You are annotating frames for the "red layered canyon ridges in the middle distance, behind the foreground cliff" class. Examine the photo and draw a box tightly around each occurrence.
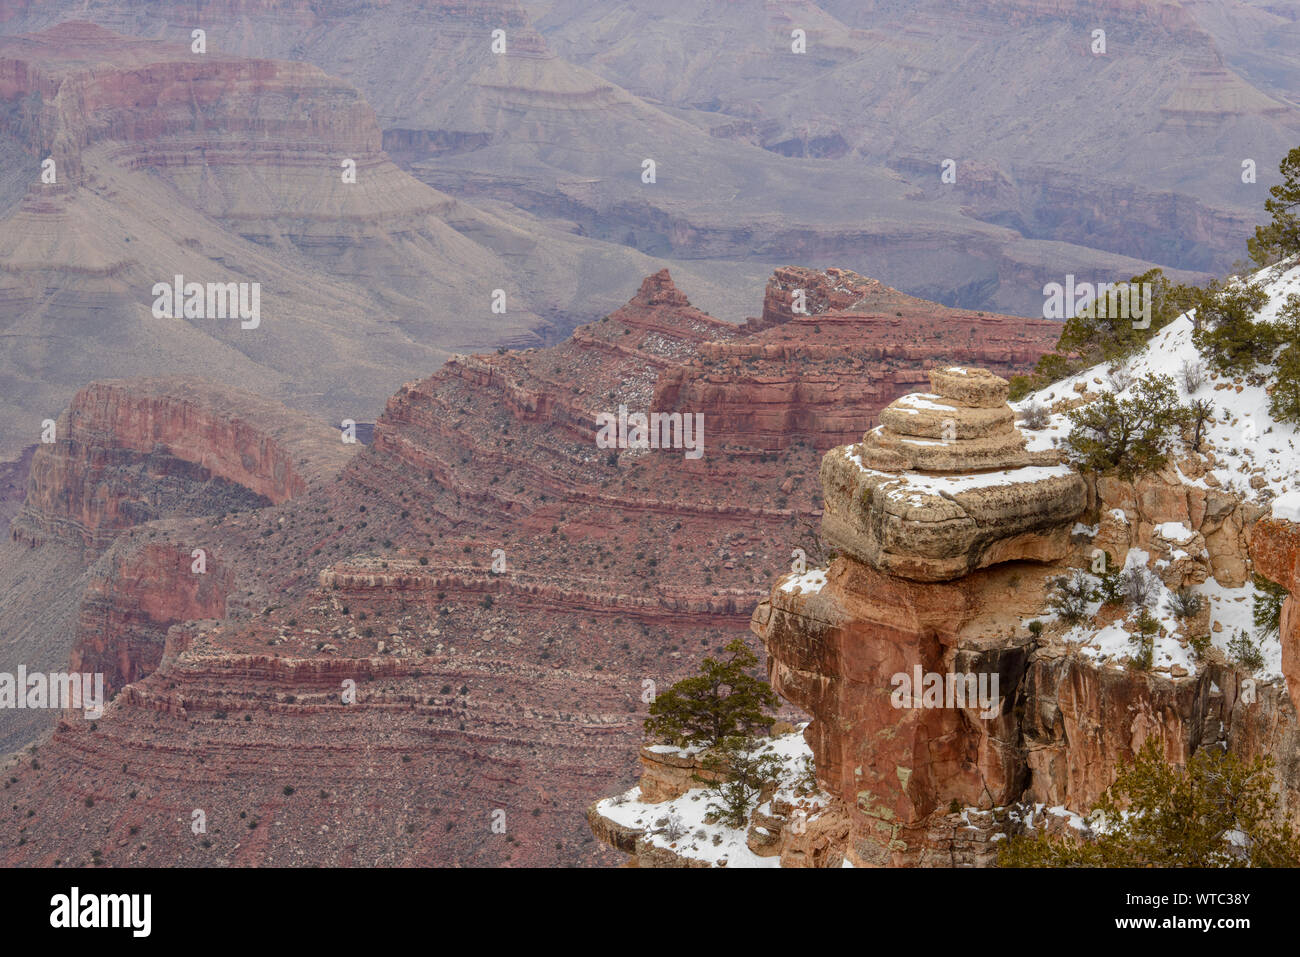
[0,267,1057,865]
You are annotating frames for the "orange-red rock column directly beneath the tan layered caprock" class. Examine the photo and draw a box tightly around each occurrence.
[754,558,1030,863]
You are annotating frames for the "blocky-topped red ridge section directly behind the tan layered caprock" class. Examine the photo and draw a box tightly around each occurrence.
[654,267,1061,454]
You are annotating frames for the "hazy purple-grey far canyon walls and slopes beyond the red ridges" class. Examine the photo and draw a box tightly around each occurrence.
[0,0,1279,475]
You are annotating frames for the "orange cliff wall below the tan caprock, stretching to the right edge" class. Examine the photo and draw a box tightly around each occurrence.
[753,479,1300,866]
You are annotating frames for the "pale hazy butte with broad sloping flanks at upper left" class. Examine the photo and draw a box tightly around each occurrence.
[0,21,762,460]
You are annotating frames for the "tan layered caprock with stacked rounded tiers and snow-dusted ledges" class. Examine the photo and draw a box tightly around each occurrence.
[822,368,1087,581]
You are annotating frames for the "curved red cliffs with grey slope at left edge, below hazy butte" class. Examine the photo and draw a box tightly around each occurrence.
[0,378,356,744]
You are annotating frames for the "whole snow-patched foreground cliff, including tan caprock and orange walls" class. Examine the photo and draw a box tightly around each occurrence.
[589,261,1300,866]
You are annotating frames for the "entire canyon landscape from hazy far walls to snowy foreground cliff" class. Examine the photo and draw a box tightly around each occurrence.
[0,0,1300,867]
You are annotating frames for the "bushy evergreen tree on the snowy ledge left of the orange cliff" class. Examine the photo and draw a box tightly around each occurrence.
[645,638,780,748]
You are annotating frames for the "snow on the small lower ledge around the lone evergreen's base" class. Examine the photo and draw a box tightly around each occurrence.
[597,724,831,867]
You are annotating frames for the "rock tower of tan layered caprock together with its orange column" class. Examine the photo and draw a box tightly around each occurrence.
[753,367,1087,865]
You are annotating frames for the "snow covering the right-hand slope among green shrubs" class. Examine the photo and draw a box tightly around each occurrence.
[1011,267,1300,680]
